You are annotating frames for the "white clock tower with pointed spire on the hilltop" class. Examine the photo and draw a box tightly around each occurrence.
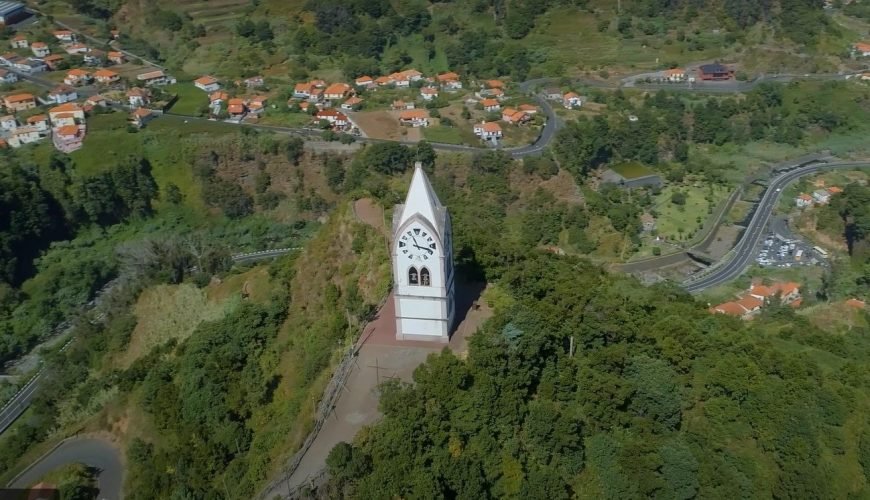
[393,162,456,342]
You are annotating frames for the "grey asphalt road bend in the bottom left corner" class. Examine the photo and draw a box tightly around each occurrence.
[8,438,124,500]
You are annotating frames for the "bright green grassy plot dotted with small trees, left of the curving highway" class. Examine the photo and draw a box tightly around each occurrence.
[655,186,728,240]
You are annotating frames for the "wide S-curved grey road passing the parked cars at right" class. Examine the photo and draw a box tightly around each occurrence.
[683,162,870,293]
